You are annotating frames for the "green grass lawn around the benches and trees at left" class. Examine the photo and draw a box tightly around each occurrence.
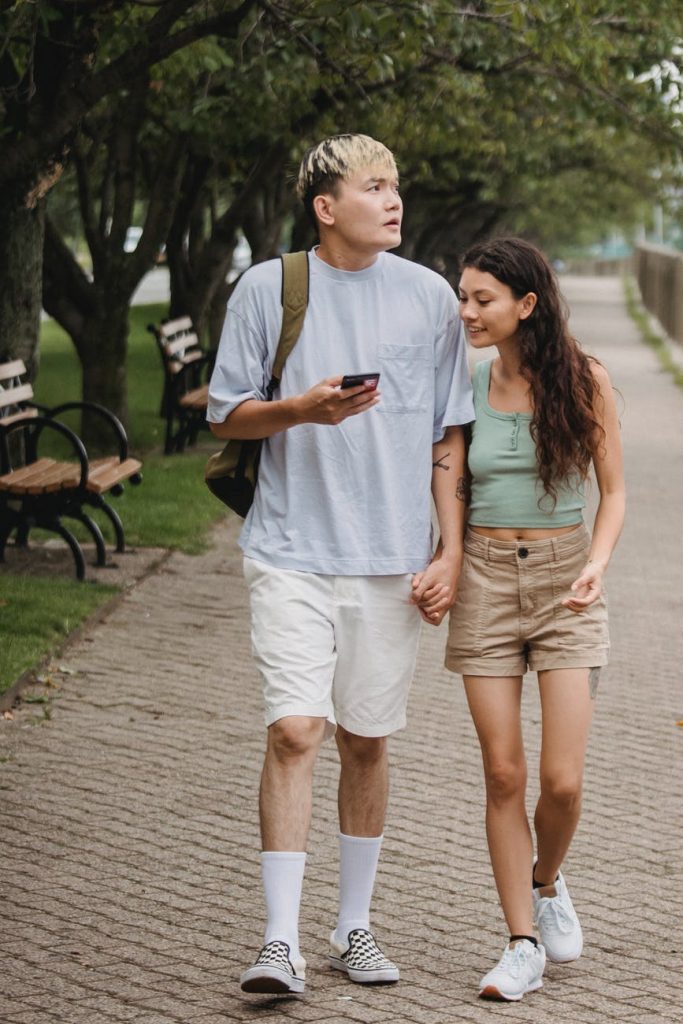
[0,305,231,693]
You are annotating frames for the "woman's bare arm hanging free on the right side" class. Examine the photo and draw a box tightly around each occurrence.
[562,362,626,611]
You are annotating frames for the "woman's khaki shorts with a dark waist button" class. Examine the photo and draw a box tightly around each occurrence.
[445,523,609,677]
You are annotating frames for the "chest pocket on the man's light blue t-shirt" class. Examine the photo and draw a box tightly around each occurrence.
[377,345,434,413]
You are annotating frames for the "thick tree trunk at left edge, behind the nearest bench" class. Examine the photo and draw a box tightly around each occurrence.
[0,185,45,380]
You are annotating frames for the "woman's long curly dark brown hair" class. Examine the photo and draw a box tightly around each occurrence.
[461,238,604,502]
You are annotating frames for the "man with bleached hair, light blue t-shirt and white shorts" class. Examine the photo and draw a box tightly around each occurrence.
[208,135,473,992]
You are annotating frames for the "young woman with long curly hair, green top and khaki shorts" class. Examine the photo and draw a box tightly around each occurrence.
[445,239,625,999]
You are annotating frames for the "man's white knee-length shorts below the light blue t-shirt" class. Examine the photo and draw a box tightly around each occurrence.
[244,557,422,736]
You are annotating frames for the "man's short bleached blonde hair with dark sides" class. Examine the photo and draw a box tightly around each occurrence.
[296,133,398,224]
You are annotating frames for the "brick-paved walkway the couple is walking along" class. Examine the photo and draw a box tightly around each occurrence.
[0,279,683,1024]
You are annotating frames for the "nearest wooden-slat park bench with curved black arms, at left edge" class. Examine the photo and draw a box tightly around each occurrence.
[0,359,142,580]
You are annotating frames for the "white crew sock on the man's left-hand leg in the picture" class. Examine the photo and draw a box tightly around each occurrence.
[261,850,306,959]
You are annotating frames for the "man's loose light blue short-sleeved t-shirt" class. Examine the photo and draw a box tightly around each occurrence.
[207,244,474,575]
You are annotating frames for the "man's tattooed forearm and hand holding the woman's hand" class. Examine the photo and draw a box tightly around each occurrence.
[413,427,466,626]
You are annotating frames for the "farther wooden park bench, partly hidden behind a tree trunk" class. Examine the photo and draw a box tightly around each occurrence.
[143,316,213,455]
